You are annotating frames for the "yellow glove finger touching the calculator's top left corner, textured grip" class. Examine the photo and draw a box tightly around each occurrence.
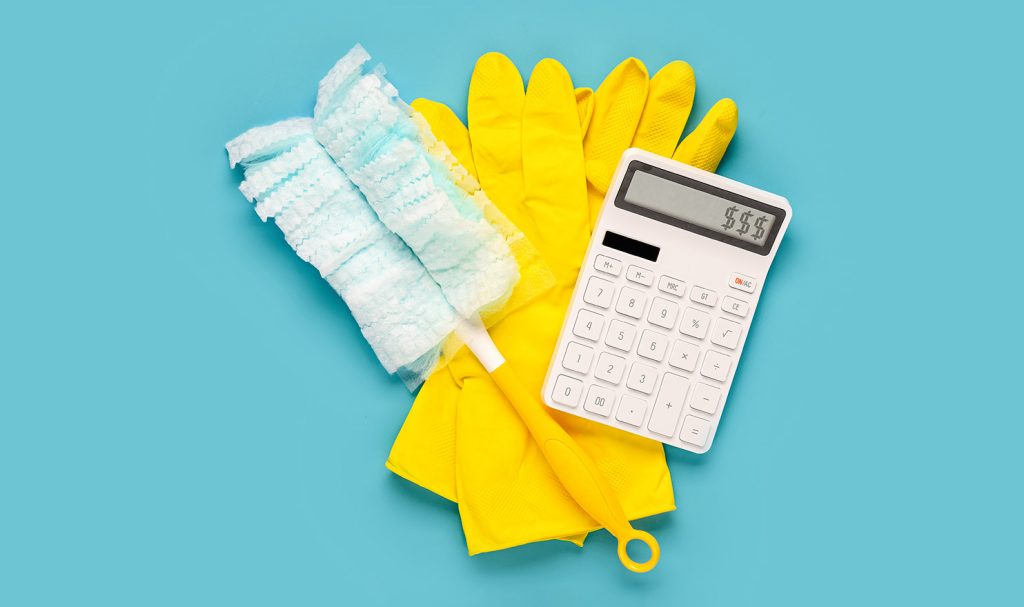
[584,57,648,192]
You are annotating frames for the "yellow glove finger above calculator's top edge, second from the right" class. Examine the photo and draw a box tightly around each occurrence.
[633,61,696,157]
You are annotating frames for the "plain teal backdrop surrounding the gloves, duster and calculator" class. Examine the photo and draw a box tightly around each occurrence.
[0,0,1024,606]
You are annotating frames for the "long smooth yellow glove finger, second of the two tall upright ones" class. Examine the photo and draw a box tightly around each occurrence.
[522,59,590,278]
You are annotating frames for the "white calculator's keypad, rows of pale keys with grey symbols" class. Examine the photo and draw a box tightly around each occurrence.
[551,249,756,449]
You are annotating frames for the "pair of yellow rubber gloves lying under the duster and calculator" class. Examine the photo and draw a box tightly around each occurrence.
[387,53,736,554]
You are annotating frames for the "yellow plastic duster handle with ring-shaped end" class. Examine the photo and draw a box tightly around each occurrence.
[490,362,662,573]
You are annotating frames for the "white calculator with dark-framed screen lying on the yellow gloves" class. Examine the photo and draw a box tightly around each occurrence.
[543,148,793,453]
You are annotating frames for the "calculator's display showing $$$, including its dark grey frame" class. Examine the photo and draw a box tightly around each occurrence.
[615,162,784,255]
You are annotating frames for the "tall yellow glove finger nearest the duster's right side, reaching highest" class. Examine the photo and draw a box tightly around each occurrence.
[467,52,525,218]
